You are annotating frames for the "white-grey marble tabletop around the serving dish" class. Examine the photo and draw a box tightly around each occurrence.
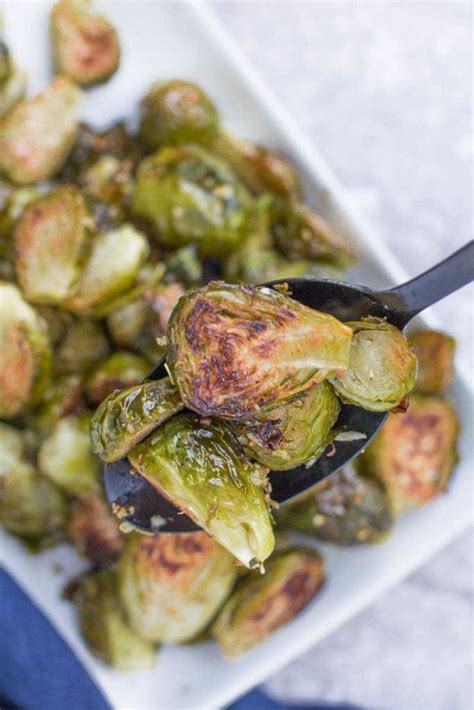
[213,0,473,710]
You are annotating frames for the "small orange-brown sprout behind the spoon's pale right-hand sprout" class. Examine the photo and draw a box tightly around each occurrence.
[409,330,456,394]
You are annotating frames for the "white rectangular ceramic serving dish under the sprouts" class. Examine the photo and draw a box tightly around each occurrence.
[0,0,472,710]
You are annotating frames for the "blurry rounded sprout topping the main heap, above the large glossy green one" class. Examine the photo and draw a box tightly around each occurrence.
[140,80,219,149]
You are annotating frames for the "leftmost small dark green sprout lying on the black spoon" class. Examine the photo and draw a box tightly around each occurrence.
[90,377,183,463]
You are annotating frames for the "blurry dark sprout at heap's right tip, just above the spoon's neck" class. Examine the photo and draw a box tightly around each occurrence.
[272,200,355,271]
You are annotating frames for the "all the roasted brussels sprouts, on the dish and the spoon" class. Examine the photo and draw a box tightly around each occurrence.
[0,0,459,670]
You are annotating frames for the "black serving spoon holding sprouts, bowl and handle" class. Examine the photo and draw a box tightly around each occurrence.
[104,241,474,533]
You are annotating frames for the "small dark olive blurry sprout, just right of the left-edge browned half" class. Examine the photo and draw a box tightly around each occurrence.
[54,316,110,375]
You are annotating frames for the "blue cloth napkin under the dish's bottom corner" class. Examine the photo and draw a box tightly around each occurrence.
[0,569,357,710]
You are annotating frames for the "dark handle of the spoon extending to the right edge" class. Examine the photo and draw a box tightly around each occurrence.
[383,240,474,325]
